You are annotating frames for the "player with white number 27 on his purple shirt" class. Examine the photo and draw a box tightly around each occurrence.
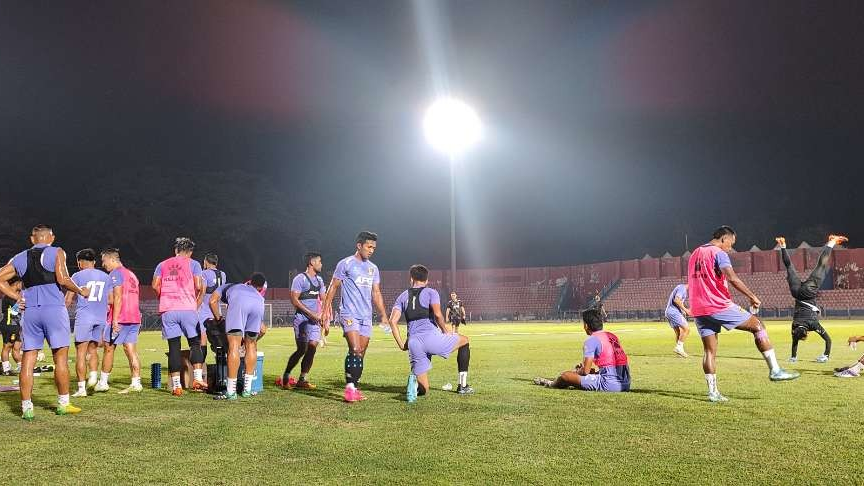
[66,248,111,398]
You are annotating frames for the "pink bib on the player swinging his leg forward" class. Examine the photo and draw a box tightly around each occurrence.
[687,244,732,316]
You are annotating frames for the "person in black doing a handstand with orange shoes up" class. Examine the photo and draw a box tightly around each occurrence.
[775,235,849,363]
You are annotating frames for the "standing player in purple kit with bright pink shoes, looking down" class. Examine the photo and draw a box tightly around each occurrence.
[322,231,390,402]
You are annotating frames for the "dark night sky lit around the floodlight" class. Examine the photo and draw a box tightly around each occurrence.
[0,0,864,282]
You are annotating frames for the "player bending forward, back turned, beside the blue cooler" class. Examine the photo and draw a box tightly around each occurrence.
[210,273,267,400]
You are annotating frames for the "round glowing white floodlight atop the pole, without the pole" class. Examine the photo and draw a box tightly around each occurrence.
[423,98,482,160]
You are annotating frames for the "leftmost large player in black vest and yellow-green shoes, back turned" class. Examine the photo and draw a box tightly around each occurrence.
[0,225,90,421]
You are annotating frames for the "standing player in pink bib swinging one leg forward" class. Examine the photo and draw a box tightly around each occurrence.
[687,226,800,402]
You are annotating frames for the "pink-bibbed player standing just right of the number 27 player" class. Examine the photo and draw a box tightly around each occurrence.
[96,248,143,394]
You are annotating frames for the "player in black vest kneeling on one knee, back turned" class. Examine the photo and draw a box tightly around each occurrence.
[390,265,474,402]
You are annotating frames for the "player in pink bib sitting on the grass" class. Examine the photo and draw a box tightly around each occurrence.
[534,309,630,392]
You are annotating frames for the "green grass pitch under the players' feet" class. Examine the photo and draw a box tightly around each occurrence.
[0,321,864,484]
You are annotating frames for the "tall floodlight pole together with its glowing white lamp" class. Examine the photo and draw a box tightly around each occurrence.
[423,97,482,292]
